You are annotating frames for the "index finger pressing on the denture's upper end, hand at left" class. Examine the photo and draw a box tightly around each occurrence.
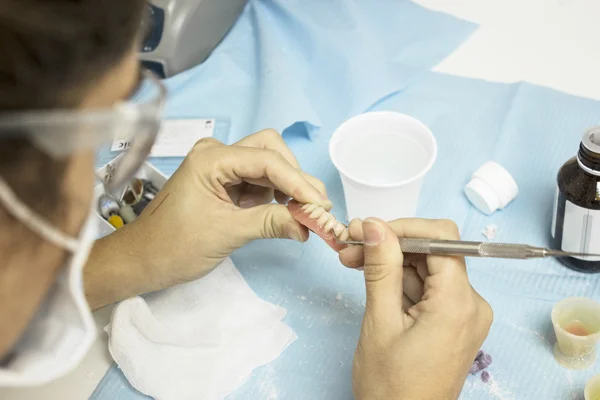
[216,146,331,208]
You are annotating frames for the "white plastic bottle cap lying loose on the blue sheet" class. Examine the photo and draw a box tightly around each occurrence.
[465,161,519,215]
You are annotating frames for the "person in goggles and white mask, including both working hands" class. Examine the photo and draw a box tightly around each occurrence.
[0,0,492,400]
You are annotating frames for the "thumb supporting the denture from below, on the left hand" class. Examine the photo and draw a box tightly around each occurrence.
[238,204,308,242]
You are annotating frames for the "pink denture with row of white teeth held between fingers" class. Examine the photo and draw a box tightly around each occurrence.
[288,200,350,251]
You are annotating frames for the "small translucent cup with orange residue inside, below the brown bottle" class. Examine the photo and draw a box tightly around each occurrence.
[551,297,600,369]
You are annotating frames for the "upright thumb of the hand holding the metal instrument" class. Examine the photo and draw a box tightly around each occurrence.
[362,218,403,321]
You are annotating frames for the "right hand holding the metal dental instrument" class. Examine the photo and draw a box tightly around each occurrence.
[340,219,493,400]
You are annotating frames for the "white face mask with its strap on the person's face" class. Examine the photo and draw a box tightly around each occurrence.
[0,178,97,386]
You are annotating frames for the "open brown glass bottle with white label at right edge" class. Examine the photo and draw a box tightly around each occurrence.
[552,127,600,273]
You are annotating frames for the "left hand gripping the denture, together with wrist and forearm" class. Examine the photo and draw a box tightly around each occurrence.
[84,130,332,308]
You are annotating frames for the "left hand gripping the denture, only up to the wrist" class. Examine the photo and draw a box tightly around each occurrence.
[142,130,332,285]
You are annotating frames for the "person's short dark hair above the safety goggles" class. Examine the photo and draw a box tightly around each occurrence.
[0,0,145,111]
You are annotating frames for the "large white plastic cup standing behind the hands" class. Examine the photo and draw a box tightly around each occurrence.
[329,111,437,221]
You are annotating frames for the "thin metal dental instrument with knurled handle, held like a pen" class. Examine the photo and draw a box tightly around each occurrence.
[338,238,600,259]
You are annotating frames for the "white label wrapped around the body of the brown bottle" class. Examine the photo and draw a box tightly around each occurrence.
[553,200,600,261]
